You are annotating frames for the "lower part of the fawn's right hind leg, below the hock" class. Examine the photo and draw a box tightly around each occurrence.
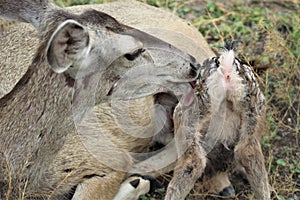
[235,135,270,200]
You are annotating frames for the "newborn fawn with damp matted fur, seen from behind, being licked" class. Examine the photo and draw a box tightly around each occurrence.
[166,41,270,200]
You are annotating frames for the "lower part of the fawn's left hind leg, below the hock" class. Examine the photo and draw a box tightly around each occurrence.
[165,143,206,200]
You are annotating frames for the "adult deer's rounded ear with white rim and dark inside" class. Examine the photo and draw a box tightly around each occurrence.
[46,20,90,73]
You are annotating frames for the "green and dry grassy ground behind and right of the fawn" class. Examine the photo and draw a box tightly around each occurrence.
[55,0,300,200]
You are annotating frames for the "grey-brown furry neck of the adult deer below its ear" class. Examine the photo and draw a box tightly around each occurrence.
[0,49,73,179]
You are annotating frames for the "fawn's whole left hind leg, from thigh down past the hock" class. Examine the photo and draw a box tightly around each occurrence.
[165,92,206,200]
